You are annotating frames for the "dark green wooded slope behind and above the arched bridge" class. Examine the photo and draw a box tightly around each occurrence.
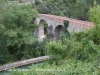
[36,0,100,20]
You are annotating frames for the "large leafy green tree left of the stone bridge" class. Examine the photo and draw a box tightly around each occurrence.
[0,4,38,61]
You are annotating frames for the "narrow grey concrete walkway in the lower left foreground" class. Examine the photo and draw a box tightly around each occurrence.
[0,56,50,71]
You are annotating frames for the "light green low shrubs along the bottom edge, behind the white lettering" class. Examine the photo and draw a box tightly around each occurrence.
[8,59,100,75]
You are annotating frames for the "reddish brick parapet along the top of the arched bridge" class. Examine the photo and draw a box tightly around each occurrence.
[40,14,95,29]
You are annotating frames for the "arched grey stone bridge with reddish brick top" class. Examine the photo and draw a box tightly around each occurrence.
[34,14,94,40]
